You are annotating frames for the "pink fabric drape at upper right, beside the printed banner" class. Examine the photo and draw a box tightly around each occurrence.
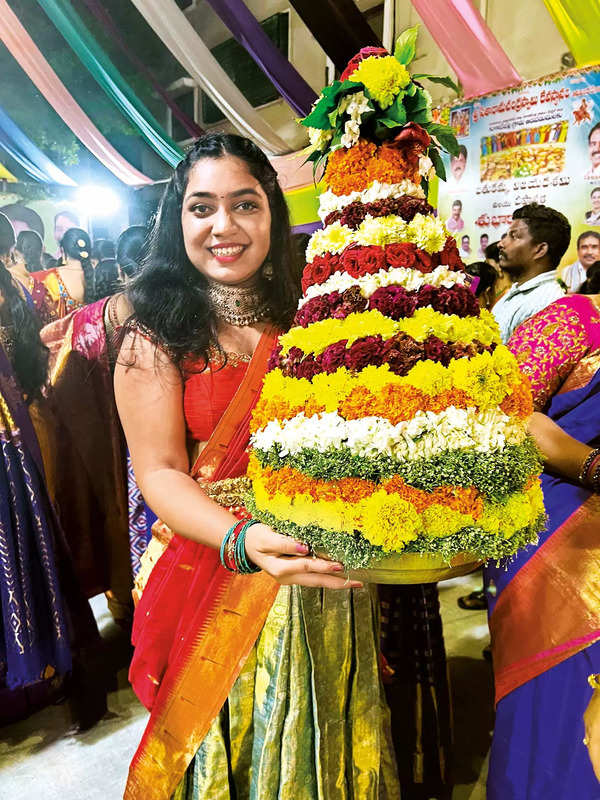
[412,0,523,99]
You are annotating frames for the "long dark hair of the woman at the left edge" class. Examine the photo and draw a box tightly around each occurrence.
[0,214,48,401]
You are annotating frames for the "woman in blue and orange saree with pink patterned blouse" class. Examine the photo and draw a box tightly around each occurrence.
[486,295,600,800]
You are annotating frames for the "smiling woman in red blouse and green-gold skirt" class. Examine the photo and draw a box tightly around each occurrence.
[115,134,399,800]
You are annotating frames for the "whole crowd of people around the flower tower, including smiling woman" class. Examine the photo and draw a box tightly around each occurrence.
[0,134,600,800]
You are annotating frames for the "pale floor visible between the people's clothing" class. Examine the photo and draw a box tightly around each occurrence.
[0,575,492,800]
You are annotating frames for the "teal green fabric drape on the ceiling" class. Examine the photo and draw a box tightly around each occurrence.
[38,0,183,167]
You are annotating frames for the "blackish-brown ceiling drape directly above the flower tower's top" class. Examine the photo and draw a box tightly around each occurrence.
[291,0,381,72]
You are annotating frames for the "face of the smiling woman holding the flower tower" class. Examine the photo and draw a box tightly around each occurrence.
[181,156,271,286]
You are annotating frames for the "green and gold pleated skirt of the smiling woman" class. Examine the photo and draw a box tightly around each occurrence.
[173,586,400,800]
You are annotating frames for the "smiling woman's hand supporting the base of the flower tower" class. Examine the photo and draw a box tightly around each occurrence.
[246,524,362,589]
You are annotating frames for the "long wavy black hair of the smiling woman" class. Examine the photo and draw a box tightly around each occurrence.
[128,133,300,366]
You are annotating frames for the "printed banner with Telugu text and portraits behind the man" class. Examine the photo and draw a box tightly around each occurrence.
[437,66,600,264]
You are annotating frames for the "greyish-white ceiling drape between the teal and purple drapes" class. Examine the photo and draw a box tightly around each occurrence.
[132,0,290,155]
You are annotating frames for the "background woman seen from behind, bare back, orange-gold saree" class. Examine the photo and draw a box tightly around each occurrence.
[44,228,94,317]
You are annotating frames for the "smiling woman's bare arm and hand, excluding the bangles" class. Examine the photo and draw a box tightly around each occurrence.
[115,334,360,588]
